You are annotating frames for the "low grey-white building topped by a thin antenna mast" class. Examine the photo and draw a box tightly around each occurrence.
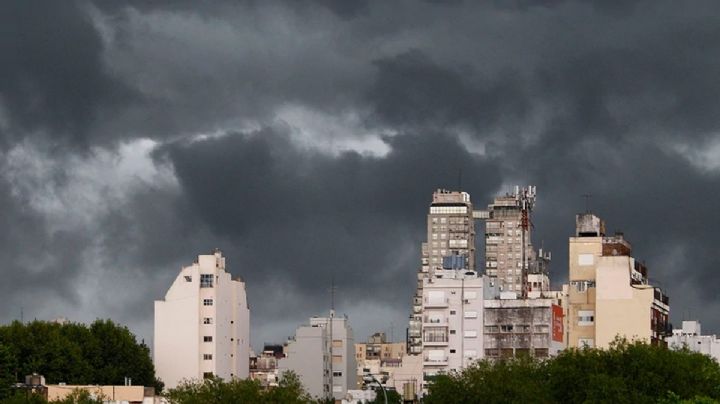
[278,313,357,400]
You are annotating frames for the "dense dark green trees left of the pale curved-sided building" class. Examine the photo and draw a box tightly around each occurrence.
[0,320,163,399]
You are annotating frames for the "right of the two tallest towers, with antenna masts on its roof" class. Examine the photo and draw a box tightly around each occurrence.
[476,186,550,298]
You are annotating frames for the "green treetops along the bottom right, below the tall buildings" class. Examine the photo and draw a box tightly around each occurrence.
[425,340,720,404]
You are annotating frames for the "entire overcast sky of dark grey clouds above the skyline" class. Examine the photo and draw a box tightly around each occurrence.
[0,0,720,347]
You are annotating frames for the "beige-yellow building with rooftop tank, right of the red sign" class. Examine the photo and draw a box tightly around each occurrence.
[566,213,670,348]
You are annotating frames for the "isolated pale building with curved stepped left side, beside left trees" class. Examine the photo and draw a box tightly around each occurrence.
[153,250,250,388]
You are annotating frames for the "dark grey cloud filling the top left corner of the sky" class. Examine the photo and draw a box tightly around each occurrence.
[0,1,131,145]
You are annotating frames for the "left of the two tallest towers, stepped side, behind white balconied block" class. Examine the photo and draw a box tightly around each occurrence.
[407,189,475,355]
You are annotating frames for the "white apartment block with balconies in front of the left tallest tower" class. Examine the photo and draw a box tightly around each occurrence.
[422,269,484,390]
